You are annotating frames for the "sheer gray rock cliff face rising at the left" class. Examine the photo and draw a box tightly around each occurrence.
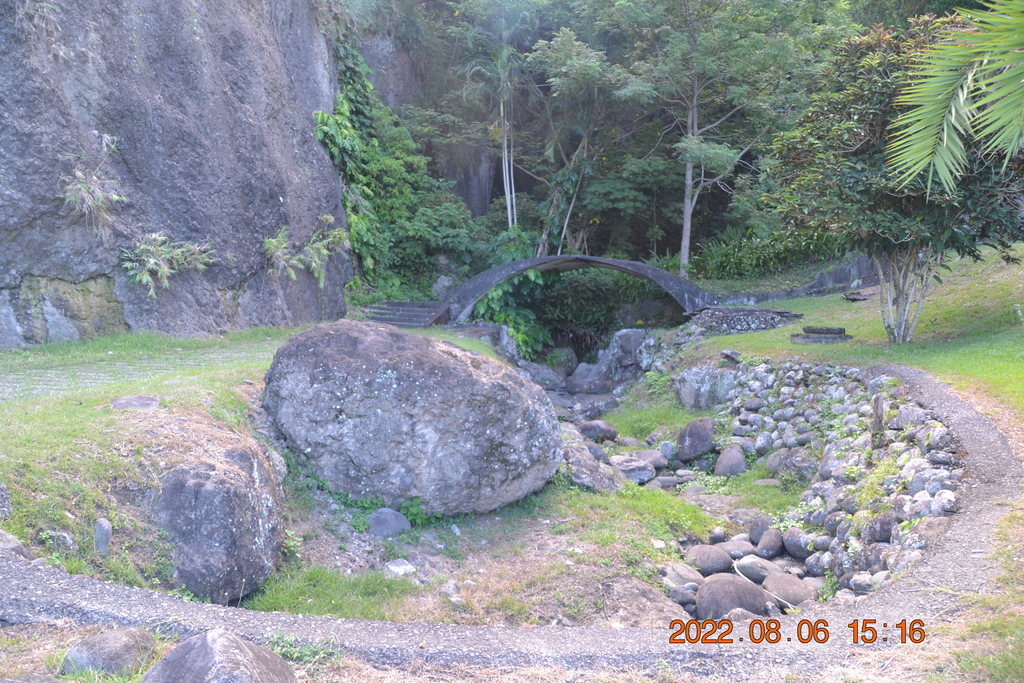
[0,0,350,347]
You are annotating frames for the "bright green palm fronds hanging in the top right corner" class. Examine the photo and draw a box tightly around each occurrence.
[889,0,1024,191]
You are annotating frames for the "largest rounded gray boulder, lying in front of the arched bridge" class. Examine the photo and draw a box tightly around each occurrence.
[263,321,562,515]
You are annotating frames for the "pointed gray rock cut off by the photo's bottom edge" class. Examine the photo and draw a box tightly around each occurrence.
[142,629,295,683]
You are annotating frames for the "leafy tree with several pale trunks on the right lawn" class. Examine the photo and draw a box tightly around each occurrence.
[772,17,1020,343]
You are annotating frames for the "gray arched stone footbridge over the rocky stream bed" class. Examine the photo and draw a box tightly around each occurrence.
[444,254,718,321]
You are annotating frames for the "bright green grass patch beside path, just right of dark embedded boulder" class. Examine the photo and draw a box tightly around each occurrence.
[242,567,419,622]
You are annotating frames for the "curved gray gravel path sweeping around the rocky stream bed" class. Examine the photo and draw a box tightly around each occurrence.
[0,366,1024,680]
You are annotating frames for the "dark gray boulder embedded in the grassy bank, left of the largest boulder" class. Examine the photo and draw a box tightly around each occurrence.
[156,449,283,604]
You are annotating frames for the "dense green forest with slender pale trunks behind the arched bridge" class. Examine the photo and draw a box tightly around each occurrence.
[317,0,1019,352]
